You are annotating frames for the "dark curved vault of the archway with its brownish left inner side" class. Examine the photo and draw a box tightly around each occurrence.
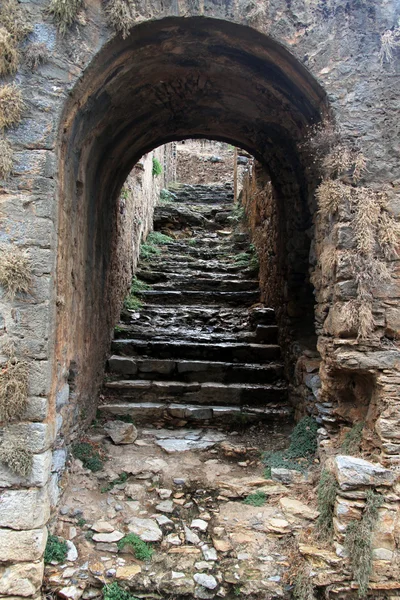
[55,17,327,446]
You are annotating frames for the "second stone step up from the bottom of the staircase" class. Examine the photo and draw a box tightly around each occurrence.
[104,379,287,406]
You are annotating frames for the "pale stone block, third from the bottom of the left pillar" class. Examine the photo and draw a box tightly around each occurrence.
[0,487,50,529]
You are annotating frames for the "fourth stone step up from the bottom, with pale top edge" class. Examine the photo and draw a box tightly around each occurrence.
[111,339,280,363]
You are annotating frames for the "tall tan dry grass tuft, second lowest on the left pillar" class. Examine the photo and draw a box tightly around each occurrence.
[0,356,28,422]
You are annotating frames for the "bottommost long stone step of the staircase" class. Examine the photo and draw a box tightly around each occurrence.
[99,402,293,427]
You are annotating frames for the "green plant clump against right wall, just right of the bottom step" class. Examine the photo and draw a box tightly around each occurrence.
[263,417,318,478]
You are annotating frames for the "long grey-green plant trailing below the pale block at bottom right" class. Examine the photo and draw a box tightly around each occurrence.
[344,490,383,598]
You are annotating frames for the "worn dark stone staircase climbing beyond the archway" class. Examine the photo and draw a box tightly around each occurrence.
[99,185,291,425]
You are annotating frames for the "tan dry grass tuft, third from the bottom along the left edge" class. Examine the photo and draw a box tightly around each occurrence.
[0,247,32,299]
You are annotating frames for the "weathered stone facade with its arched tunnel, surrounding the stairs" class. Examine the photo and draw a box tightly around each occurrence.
[0,0,400,597]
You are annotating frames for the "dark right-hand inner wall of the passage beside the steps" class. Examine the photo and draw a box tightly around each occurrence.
[240,163,321,417]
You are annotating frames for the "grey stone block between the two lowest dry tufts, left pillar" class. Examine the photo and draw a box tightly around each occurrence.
[2,423,55,454]
